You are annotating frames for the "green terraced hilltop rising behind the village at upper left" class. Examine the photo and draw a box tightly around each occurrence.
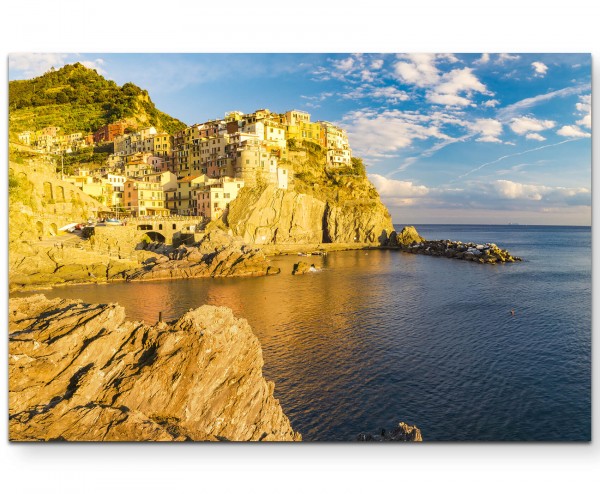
[8,63,185,134]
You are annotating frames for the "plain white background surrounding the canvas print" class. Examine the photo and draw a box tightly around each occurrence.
[0,0,600,494]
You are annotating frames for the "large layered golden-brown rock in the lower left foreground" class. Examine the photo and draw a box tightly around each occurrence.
[9,295,301,441]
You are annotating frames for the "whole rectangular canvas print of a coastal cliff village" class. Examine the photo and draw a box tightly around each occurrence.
[7,53,592,442]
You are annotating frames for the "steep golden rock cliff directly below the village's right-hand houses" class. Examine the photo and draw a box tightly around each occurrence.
[225,149,393,245]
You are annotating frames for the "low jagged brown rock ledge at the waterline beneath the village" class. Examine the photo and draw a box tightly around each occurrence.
[127,245,279,281]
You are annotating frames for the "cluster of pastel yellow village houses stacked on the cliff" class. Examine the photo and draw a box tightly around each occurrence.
[18,109,352,220]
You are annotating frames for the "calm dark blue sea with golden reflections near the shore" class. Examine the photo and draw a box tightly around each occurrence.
[22,225,592,441]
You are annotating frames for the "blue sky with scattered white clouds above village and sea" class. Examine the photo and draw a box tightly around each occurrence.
[9,53,592,225]
